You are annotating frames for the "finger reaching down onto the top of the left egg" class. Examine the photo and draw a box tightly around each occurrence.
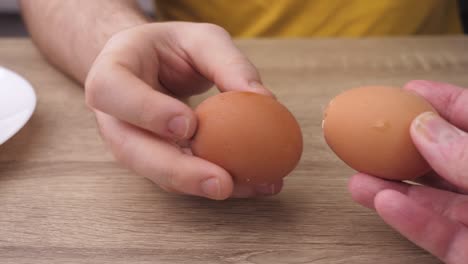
[173,24,272,95]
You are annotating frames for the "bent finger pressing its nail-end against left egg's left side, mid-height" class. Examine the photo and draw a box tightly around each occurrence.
[86,60,196,139]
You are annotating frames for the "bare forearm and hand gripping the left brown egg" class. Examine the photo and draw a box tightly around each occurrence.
[20,0,282,200]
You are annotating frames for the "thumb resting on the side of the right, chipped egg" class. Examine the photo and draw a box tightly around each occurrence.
[411,112,468,190]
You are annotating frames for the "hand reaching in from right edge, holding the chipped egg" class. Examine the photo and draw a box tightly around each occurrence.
[349,81,468,264]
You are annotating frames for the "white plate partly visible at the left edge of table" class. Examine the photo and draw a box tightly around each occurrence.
[0,67,36,145]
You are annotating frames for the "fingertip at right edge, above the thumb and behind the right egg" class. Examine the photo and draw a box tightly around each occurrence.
[404,81,468,130]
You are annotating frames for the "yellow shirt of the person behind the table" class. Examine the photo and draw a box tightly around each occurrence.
[155,0,462,37]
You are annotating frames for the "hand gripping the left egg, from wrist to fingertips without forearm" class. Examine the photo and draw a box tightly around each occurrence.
[85,22,282,200]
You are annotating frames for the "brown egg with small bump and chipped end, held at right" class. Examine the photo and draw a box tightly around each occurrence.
[323,86,436,180]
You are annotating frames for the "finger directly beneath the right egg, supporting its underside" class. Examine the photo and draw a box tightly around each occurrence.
[348,174,468,225]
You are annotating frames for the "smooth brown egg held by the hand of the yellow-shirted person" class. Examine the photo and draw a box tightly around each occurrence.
[191,92,302,184]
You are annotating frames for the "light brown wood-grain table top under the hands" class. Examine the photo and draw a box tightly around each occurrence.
[0,37,468,264]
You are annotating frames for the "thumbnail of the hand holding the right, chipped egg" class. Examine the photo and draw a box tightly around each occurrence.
[413,112,461,144]
